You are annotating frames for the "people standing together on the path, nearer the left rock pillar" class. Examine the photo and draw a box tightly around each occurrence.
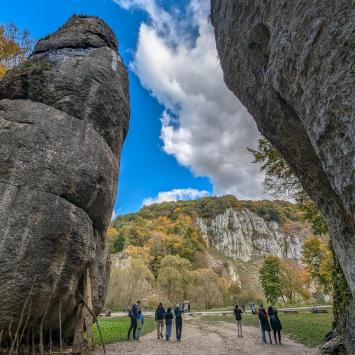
[127,301,185,341]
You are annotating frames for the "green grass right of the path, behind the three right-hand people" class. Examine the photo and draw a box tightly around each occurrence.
[201,312,332,347]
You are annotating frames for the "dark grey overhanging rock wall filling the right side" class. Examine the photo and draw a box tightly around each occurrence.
[211,0,355,354]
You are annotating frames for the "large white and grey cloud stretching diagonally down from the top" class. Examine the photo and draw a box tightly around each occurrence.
[115,0,266,199]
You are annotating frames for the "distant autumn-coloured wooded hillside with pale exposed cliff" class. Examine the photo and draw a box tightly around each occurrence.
[107,195,330,308]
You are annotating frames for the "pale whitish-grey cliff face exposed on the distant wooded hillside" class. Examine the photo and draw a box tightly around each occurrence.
[196,208,310,262]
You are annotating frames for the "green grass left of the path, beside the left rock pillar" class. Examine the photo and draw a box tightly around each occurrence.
[93,317,155,346]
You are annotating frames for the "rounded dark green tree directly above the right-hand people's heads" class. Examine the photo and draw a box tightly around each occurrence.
[259,256,283,304]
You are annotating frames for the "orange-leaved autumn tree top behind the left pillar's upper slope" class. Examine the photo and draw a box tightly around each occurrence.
[0,23,34,78]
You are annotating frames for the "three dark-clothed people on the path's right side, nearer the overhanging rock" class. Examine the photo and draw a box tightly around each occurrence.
[234,304,282,345]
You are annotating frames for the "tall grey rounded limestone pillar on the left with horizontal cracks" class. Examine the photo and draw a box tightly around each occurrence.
[0,16,129,348]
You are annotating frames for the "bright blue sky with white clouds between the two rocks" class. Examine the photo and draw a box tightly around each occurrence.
[0,0,263,214]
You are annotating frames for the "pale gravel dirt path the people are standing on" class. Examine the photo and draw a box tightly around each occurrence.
[95,320,319,355]
